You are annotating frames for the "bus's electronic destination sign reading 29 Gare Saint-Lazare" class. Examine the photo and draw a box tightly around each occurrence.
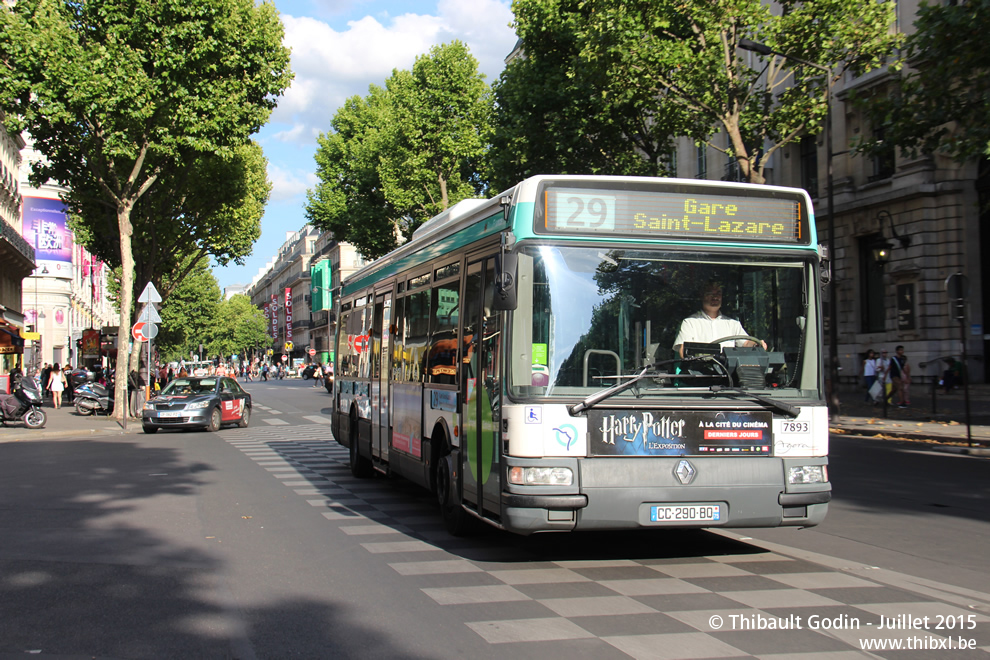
[543,187,808,243]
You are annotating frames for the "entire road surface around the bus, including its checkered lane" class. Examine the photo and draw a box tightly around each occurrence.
[0,380,990,660]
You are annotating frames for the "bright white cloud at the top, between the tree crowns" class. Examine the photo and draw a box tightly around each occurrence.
[272,0,516,144]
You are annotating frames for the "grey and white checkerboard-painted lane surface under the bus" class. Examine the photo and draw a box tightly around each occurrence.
[225,426,990,660]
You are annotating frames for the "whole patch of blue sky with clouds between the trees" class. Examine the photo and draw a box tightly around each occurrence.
[213,0,516,288]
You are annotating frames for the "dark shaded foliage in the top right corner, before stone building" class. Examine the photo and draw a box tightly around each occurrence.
[857,0,990,161]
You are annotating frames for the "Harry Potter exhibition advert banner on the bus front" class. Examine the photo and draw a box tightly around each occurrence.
[588,409,773,456]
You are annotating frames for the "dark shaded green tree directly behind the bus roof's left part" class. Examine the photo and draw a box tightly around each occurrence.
[490,0,697,190]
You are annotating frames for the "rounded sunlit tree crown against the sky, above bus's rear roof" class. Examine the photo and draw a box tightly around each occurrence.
[306,41,492,258]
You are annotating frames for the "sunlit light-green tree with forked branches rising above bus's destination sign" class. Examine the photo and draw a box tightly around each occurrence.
[508,0,898,183]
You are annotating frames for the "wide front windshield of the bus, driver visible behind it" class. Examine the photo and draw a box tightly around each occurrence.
[509,245,820,398]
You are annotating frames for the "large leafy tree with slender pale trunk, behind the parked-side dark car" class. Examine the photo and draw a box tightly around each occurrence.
[0,0,291,419]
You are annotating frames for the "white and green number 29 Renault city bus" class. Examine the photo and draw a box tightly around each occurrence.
[331,175,831,535]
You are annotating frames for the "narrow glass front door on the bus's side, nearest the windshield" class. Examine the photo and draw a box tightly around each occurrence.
[460,259,502,519]
